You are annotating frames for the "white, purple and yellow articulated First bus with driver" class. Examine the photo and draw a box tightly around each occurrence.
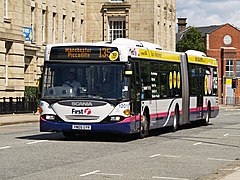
[39,38,219,138]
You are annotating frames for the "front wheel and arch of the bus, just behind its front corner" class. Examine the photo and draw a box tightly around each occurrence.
[139,107,150,139]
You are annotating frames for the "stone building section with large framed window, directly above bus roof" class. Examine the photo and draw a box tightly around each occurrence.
[86,0,176,50]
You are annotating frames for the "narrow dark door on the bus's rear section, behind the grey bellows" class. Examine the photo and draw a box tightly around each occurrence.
[195,66,204,119]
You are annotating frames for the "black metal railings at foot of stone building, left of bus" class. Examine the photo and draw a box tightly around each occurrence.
[0,97,37,114]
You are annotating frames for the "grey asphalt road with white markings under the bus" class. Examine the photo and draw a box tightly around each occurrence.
[0,110,240,180]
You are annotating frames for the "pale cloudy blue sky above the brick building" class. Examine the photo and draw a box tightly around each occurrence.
[176,0,240,28]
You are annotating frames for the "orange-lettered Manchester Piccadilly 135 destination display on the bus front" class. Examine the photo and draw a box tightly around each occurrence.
[50,46,119,61]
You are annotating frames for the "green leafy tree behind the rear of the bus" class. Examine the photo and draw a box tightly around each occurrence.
[177,27,206,52]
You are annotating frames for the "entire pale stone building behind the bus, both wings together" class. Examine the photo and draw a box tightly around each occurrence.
[0,0,176,98]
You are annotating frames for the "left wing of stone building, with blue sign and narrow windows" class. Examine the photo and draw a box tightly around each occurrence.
[0,0,85,97]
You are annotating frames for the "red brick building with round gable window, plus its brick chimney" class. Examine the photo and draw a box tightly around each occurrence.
[177,18,240,104]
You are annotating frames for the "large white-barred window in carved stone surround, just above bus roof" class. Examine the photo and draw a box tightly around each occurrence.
[108,17,126,41]
